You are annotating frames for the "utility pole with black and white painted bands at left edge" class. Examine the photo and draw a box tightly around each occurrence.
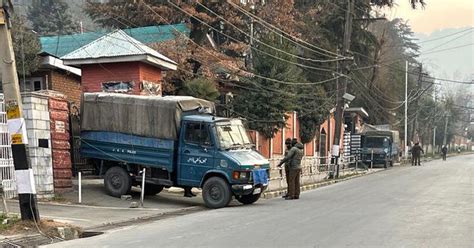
[0,0,39,221]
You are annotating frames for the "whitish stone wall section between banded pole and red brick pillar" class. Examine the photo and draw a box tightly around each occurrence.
[22,93,54,198]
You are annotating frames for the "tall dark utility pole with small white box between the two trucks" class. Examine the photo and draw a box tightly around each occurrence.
[332,0,354,178]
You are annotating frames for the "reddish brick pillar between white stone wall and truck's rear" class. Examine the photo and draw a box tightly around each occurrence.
[49,94,72,192]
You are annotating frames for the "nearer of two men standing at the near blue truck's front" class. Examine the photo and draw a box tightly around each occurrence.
[278,139,304,200]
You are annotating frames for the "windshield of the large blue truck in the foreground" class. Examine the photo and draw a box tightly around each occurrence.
[216,121,251,149]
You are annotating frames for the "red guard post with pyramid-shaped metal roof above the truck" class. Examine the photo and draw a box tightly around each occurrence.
[61,30,177,95]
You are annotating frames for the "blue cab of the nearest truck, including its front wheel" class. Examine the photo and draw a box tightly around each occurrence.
[176,115,270,205]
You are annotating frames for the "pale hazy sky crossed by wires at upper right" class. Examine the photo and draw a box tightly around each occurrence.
[384,0,474,81]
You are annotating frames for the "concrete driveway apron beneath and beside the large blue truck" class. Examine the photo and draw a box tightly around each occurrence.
[7,179,205,230]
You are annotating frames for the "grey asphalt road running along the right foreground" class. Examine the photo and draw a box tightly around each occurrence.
[43,155,474,247]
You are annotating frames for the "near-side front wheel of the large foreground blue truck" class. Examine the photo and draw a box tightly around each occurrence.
[202,177,232,208]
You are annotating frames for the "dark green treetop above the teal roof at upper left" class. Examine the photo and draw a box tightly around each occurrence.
[28,0,78,35]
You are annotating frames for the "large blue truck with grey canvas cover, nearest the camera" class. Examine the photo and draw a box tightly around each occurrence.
[81,93,270,208]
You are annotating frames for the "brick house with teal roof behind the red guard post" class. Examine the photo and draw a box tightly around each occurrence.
[2,24,190,104]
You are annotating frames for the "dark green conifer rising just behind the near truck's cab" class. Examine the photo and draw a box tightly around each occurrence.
[233,34,305,138]
